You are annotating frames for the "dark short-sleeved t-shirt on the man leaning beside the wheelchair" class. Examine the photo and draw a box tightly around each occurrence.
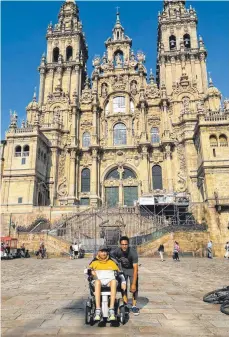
[111,248,138,269]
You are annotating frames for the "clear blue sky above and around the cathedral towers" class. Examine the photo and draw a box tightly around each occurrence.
[1,1,229,139]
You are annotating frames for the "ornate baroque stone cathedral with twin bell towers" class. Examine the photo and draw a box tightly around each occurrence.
[1,0,229,236]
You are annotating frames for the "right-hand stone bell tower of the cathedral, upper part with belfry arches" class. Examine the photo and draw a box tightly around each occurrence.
[157,0,208,96]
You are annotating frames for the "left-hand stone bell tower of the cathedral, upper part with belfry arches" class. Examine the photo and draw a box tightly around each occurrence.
[39,0,88,105]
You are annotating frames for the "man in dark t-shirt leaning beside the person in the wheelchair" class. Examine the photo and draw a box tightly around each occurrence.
[111,236,139,315]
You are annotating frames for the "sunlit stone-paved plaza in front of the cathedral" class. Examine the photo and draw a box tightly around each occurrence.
[2,258,229,337]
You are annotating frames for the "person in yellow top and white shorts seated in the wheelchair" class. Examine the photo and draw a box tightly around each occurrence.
[86,246,126,321]
